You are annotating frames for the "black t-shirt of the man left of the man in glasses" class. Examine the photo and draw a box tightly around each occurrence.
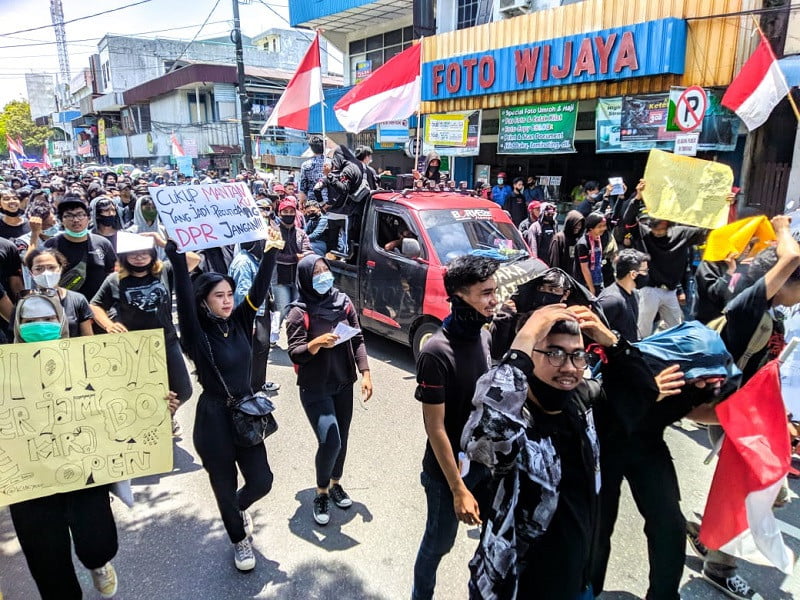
[415,330,491,480]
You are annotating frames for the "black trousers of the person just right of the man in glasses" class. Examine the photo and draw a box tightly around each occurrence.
[591,434,686,600]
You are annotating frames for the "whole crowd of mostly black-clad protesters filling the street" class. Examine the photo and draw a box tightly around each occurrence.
[0,152,800,600]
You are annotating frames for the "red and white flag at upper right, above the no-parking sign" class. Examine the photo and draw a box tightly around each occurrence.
[722,35,789,131]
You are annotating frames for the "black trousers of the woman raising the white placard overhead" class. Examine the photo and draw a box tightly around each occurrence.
[193,392,273,544]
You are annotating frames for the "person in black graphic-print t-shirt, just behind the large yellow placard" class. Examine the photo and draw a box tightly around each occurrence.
[92,248,192,402]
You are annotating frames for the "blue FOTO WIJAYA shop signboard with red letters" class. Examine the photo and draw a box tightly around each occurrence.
[422,17,687,101]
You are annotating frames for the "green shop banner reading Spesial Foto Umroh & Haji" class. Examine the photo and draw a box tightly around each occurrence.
[497,102,578,154]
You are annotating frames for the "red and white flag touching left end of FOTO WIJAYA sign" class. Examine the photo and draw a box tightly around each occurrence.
[333,42,422,133]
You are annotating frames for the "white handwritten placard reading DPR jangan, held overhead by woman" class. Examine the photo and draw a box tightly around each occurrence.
[150,182,267,252]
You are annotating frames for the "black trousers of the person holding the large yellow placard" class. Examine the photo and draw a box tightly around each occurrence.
[9,485,117,600]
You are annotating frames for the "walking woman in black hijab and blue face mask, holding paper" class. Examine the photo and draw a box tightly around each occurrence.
[286,254,372,525]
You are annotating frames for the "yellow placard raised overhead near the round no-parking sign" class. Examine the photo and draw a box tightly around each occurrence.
[642,150,733,229]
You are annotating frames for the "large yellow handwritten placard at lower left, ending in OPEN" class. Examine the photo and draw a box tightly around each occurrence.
[0,329,172,506]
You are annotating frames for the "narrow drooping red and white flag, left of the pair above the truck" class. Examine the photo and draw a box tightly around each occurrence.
[261,32,324,134]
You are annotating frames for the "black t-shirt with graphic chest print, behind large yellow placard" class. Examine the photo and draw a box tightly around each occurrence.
[92,263,177,338]
